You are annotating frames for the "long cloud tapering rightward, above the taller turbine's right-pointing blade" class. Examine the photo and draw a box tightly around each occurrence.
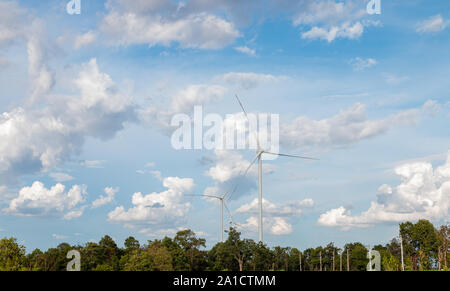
[280,103,420,148]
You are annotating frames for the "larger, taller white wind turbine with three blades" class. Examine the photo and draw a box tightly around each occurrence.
[234,95,318,242]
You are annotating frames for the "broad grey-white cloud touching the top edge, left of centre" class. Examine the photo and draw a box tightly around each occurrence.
[101,0,240,49]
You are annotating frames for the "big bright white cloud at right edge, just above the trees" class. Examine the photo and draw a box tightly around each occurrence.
[318,152,450,230]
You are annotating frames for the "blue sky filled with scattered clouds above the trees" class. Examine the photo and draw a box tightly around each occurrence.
[0,0,450,250]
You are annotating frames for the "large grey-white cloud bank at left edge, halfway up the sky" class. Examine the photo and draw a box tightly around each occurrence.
[0,59,134,182]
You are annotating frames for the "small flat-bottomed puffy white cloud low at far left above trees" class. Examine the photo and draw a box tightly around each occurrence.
[4,181,87,219]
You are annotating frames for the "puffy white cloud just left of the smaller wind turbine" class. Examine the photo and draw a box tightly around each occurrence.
[108,177,195,229]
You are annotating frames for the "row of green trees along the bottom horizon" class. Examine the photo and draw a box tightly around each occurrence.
[0,220,450,271]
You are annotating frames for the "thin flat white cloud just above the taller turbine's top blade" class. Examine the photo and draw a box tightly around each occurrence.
[215,72,283,90]
